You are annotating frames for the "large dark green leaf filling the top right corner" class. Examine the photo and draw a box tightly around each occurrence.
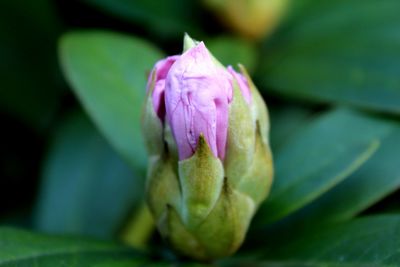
[257,0,400,114]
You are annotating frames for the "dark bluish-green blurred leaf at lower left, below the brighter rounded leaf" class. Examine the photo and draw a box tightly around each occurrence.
[35,113,144,238]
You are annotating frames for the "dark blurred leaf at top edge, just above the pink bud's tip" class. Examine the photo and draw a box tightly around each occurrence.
[82,0,202,38]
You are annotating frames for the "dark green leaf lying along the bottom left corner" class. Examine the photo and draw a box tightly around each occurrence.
[0,227,144,267]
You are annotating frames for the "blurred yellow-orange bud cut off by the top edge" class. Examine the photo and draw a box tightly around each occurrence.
[204,0,288,39]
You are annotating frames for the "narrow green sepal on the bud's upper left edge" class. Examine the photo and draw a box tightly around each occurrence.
[141,71,164,157]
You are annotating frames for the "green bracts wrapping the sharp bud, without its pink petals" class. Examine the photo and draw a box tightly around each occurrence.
[142,36,273,260]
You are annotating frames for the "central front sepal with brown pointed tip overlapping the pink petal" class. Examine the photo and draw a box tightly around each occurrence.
[178,135,224,230]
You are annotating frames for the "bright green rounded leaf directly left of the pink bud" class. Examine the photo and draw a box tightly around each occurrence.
[60,31,163,171]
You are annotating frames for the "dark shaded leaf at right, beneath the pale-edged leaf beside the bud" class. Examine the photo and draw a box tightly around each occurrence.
[250,120,400,248]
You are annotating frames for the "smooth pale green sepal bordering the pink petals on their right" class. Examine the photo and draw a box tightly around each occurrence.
[224,72,255,187]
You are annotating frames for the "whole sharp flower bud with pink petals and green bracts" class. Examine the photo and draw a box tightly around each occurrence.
[142,36,273,260]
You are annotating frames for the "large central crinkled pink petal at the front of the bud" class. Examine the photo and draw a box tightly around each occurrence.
[165,42,232,160]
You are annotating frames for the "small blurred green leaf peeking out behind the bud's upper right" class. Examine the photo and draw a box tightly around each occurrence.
[205,36,258,73]
